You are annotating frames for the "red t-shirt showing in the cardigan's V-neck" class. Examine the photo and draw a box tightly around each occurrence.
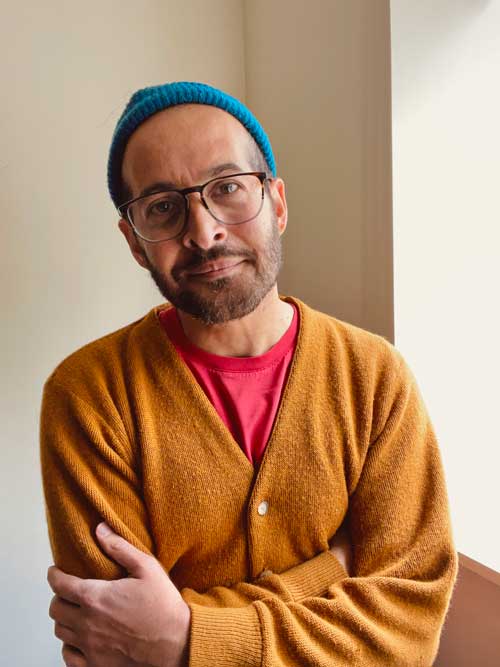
[160,304,299,465]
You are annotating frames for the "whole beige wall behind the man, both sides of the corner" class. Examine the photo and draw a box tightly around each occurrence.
[0,0,393,667]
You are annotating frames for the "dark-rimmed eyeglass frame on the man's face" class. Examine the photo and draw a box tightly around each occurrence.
[117,171,272,243]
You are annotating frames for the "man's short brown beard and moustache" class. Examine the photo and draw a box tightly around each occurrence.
[144,220,283,325]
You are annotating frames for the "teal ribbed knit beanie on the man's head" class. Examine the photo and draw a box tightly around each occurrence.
[108,81,276,207]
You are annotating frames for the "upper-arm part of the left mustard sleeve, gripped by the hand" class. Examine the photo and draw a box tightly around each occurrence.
[40,376,154,579]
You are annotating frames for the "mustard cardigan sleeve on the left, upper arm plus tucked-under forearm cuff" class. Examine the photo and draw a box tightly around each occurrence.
[40,377,347,607]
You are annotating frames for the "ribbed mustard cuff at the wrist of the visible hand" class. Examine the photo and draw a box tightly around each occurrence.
[189,603,262,667]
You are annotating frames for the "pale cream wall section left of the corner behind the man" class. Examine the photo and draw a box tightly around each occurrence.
[0,0,244,667]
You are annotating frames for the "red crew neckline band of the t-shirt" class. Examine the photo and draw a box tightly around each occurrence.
[160,303,299,373]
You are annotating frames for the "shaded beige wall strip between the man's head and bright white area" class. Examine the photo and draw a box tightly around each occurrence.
[245,0,393,340]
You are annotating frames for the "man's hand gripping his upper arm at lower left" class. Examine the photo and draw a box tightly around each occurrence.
[47,523,190,667]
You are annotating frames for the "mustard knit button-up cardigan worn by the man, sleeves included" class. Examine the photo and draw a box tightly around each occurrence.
[40,299,457,667]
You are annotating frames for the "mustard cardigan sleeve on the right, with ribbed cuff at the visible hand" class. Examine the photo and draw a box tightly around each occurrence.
[189,353,458,667]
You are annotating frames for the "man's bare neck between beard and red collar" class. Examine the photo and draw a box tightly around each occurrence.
[177,286,293,357]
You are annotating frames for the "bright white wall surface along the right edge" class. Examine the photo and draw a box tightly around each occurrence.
[391,0,500,570]
